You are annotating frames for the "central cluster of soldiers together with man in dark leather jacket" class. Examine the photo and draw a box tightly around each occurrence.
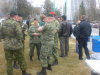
[29,16,72,75]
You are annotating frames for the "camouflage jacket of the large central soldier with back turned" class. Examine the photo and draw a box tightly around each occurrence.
[41,20,57,44]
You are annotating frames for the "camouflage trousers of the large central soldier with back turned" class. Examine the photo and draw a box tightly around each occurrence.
[40,43,54,67]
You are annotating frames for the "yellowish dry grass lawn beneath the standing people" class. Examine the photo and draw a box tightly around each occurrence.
[0,37,90,75]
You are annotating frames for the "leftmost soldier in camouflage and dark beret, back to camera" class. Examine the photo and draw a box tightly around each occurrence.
[2,12,31,75]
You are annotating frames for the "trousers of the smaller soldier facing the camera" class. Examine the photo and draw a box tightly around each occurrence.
[30,43,41,59]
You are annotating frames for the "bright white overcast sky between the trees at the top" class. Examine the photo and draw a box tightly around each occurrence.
[28,0,71,19]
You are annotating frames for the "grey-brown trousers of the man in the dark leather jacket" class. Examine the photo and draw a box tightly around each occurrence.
[60,37,69,56]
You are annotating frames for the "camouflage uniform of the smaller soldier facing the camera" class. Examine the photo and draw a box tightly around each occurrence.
[29,25,41,58]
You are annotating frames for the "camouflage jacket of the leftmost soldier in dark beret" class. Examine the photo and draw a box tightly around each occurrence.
[2,19,23,50]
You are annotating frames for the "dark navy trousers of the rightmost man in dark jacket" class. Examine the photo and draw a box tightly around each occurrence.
[78,37,90,59]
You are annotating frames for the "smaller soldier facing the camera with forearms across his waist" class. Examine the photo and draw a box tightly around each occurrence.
[29,19,41,61]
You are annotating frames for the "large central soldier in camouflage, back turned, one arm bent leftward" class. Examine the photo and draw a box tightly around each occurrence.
[37,17,56,75]
